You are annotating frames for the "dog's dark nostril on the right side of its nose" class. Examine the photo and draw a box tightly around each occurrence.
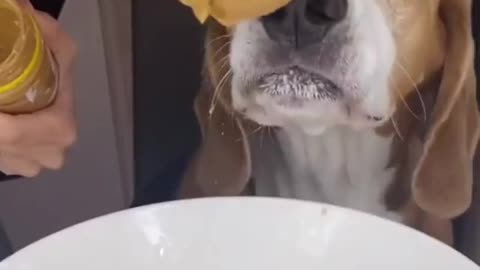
[305,0,348,25]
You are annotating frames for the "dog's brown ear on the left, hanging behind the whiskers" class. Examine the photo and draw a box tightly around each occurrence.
[180,21,251,198]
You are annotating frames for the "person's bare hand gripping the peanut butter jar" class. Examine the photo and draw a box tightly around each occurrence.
[0,7,76,178]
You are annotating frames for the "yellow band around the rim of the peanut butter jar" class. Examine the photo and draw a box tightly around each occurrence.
[0,3,43,93]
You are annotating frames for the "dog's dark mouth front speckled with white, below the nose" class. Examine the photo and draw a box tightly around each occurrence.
[258,66,343,101]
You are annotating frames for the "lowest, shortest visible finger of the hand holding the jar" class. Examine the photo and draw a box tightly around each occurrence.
[0,153,41,178]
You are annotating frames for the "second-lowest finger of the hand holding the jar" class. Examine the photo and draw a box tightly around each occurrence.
[1,146,66,170]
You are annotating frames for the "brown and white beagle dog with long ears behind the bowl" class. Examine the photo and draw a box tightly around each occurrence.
[180,0,480,247]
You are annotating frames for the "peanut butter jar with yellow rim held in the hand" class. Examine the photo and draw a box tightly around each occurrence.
[0,0,58,114]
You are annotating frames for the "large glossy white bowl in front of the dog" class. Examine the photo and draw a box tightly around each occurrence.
[0,198,480,270]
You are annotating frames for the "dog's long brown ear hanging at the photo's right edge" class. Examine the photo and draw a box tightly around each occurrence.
[413,0,480,218]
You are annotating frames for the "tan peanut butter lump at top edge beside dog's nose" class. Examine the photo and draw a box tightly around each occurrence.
[180,0,291,26]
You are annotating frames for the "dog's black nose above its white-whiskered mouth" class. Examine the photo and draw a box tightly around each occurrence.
[261,0,348,48]
